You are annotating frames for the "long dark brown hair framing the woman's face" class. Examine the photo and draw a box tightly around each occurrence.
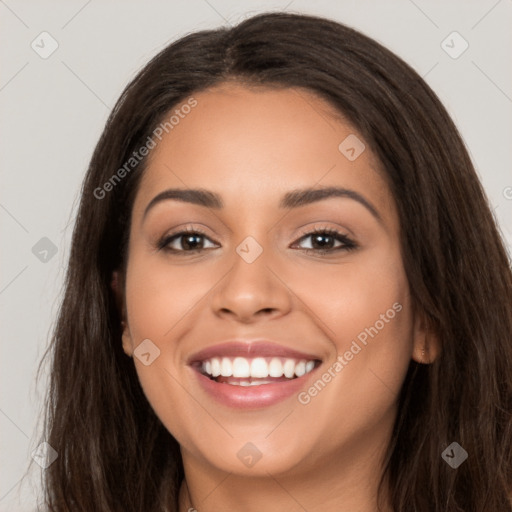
[37,13,512,512]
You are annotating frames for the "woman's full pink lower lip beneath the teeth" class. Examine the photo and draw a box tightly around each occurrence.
[192,368,318,409]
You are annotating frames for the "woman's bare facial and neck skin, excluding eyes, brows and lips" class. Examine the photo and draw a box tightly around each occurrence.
[117,83,438,512]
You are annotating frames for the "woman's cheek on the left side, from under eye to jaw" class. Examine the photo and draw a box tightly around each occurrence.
[126,246,222,442]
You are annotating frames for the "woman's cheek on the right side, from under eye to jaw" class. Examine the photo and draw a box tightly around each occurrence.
[292,246,413,439]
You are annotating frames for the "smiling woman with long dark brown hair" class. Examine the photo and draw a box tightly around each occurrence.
[39,13,512,512]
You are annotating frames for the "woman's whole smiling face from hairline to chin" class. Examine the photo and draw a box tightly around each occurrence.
[119,84,424,475]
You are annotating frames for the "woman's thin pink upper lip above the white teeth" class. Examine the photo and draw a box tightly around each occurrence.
[188,339,320,364]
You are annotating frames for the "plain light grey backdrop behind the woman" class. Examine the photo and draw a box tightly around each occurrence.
[0,0,512,511]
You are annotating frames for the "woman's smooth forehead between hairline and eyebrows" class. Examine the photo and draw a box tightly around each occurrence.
[136,83,392,220]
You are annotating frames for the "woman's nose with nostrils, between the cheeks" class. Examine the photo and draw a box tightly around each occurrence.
[212,244,293,324]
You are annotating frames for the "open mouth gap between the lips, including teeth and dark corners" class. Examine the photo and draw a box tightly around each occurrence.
[193,357,321,386]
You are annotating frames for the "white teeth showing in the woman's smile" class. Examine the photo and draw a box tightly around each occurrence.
[201,357,315,380]
